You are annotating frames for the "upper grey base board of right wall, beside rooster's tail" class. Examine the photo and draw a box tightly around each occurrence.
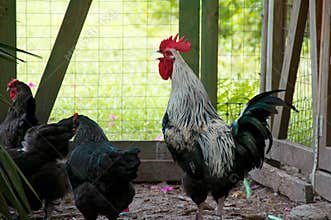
[266,139,314,176]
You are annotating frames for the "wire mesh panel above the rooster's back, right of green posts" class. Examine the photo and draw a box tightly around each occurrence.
[218,0,262,122]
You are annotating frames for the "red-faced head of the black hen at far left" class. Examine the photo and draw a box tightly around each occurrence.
[7,79,32,102]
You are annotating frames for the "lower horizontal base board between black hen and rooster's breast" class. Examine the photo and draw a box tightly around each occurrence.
[135,160,183,182]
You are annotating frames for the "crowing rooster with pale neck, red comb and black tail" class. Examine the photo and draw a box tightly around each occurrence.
[158,35,296,219]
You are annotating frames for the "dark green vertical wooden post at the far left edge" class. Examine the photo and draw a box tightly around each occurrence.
[0,0,16,122]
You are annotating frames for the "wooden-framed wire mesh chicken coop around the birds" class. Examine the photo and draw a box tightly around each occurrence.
[0,0,331,218]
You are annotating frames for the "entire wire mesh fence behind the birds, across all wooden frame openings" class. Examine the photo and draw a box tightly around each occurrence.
[17,0,312,145]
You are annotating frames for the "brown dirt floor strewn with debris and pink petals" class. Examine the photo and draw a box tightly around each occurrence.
[29,180,296,220]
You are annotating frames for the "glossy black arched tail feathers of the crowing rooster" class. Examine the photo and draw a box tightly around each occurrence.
[232,90,298,171]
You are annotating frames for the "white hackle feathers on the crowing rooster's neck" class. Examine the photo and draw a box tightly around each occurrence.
[167,50,219,128]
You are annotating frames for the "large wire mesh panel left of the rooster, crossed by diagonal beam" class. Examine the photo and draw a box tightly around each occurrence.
[17,0,178,140]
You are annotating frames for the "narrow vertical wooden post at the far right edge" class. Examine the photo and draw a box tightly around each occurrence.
[318,0,331,148]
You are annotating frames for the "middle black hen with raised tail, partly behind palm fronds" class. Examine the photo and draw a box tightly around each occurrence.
[7,117,74,219]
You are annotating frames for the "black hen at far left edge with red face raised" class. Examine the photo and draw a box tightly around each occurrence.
[0,79,38,149]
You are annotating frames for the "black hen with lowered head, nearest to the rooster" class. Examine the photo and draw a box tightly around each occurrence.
[67,114,140,220]
